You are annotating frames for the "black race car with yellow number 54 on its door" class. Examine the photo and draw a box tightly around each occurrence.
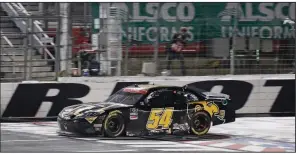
[57,84,235,137]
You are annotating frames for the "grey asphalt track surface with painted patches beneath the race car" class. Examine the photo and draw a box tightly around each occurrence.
[1,117,296,153]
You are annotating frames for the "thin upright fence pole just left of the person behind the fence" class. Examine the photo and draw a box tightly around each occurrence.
[153,5,160,75]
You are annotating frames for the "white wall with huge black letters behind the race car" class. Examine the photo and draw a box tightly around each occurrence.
[1,74,295,117]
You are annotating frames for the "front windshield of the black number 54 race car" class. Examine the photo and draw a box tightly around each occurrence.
[105,90,144,105]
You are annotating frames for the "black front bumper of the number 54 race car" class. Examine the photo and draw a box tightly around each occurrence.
[57,117,101,135]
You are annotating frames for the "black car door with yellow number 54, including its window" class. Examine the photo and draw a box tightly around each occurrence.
[128,89,174,134]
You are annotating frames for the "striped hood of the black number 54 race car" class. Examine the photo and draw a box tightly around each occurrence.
[60,102,132,117]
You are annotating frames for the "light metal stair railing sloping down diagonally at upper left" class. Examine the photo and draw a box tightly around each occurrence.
[1,3,55,59]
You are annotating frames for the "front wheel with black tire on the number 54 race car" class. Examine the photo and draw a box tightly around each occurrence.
[103,112,125,137]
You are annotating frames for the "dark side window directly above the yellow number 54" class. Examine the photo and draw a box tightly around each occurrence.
[147,90,174,108]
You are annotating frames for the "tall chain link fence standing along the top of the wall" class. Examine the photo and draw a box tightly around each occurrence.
[0,3,296,81]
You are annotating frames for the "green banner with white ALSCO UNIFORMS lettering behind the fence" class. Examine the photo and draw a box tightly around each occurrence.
[92,2,296,52]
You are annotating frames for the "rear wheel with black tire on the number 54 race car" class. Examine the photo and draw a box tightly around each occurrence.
[190,112,211,136]
